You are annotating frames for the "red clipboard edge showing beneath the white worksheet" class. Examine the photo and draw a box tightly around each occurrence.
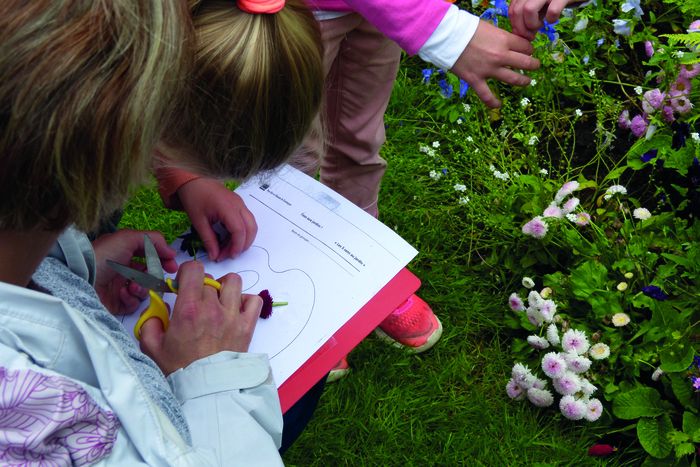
[278,268,420,413]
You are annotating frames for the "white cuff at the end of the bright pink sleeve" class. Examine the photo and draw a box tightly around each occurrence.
[418,5,479,70]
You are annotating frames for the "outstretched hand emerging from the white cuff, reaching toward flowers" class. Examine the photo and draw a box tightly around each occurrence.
[451,20,540,108]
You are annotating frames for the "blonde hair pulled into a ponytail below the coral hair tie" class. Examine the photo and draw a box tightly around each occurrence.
[164,0,323,180]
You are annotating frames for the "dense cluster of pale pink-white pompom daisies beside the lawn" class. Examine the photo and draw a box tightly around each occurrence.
[506,292,610,422]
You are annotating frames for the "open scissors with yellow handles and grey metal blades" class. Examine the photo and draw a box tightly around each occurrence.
[107,235,221,340]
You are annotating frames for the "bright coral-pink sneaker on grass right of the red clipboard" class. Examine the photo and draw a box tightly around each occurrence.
[374,294,442,353]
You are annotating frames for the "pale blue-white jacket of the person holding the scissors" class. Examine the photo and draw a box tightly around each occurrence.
[0,231,282,466]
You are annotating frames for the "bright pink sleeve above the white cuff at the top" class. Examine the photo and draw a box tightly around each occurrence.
[308,0,451,55]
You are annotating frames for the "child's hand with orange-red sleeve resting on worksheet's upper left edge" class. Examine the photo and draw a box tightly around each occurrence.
[177,178,258,261]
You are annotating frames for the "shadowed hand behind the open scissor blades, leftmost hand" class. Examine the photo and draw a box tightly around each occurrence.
[92,230,177,315]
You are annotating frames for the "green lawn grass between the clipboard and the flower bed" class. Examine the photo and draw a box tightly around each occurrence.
[122,56,624,466]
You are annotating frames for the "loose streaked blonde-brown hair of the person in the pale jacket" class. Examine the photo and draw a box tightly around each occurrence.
[0,0,191,231]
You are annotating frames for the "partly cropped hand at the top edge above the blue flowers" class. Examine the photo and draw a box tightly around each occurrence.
[508,0,581,40]
